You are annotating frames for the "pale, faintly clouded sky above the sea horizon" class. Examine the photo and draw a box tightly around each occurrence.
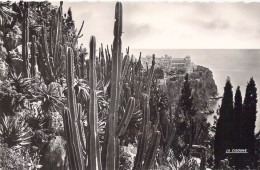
[52,1,260,49]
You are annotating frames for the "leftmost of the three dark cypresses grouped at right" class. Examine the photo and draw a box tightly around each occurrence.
[214,78,233,168]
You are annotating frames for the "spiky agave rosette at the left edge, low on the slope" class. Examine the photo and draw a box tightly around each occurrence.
[0,115,32,147]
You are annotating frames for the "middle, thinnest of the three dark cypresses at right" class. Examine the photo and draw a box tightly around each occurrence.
[232,86,243,169]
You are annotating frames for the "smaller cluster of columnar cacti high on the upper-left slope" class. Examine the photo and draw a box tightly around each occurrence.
[22,2,65,84]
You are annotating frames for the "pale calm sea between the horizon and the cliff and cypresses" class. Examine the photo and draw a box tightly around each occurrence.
[131,49,260,132]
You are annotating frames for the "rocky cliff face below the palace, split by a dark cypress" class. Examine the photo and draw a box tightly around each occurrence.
[167,66,218,113]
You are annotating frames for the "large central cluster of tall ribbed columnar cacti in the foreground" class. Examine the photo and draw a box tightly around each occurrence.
[61,2,161,169]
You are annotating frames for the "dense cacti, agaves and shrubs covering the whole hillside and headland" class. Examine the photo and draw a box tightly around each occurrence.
[0,1,257,170]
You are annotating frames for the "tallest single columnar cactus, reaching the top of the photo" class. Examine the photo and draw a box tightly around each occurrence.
[106,2,122,170]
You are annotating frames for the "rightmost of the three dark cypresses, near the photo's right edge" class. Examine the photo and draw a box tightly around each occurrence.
[242,78,257,168]
